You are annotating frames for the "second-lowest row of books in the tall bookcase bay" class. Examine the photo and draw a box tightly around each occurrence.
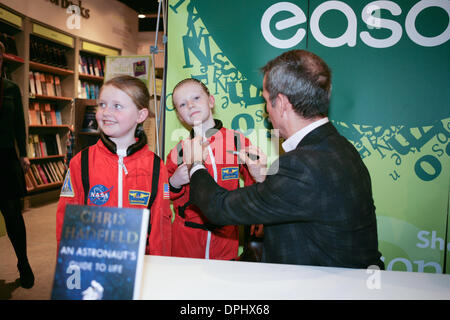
[28,133,62,158]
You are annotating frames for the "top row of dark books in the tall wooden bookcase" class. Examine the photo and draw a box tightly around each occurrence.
[30,37,68,69]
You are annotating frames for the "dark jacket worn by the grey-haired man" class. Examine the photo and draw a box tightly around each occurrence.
[190,123,384,269]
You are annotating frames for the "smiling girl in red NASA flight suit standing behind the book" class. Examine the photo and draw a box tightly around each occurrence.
[56,76,172,256]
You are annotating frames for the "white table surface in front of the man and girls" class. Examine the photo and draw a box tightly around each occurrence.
[141,256,450,300]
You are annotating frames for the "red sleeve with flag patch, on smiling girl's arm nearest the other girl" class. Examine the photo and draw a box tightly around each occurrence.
[146,156,172,256]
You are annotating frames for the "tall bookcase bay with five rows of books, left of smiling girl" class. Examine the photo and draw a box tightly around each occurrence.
[27,21,75,194]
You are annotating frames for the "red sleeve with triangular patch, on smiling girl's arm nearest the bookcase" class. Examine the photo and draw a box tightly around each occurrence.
[56,154,84,248]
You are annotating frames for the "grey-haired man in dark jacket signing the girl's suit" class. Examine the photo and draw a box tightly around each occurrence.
[184,50,384,269]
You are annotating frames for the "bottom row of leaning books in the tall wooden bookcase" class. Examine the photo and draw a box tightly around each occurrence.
[25,160,65,191]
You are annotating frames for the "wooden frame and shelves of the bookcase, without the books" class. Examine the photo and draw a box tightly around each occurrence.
[0,3,121,202]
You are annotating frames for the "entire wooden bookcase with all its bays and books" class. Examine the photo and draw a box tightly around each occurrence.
[0,3,120,205]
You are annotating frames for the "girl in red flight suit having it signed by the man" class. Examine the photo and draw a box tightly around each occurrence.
[166,78,264,260]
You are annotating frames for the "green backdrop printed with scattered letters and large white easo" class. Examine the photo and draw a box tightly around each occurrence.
[164,0,450,273]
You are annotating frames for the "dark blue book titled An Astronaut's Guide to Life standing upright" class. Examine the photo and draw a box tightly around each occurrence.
[51,205,149,300]
